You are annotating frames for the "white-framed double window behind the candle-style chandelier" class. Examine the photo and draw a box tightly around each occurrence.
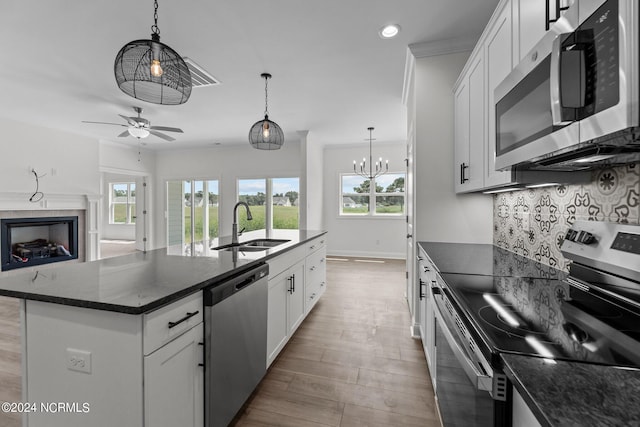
[340,173,405,216]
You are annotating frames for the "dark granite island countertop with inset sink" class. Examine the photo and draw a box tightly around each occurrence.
[0,230,326,314]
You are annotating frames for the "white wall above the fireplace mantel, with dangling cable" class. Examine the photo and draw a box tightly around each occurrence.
[0,119,100,199]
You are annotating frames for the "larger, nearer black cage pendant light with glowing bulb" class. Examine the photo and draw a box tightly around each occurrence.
[113,0,191,105]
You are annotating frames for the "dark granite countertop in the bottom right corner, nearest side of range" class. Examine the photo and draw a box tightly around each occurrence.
[501,354,640,427]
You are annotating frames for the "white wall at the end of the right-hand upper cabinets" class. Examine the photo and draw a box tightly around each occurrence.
[409,53,493,243]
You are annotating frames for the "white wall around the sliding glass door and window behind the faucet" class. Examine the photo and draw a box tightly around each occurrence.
[153,141,303,247]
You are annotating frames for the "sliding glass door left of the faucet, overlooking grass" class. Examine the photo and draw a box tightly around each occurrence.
[167,180,220,245]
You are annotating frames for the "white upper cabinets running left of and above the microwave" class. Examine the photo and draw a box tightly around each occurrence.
[453,0,575,193]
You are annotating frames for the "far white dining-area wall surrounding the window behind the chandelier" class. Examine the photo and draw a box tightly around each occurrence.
[324,142,406,258]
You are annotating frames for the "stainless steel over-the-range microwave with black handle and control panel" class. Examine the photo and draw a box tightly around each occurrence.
[494,0,640,170]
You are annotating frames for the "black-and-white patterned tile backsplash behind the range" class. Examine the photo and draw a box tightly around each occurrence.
[493,164,640,271]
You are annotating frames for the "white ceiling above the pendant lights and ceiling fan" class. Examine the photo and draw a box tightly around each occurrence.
[0,0,497,149]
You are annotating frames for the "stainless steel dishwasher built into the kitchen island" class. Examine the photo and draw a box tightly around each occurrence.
[204,264,269,427]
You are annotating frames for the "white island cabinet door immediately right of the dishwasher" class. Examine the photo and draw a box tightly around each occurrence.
[267,271,289,366]
